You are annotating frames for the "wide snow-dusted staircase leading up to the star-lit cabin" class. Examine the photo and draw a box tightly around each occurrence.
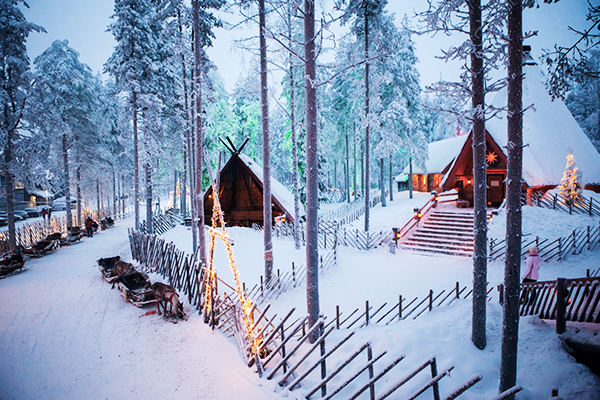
[401,209,489,257]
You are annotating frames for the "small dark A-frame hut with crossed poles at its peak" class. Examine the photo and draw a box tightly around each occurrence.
[204,146,304,227]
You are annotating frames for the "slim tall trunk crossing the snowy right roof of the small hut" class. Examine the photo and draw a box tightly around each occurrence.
[258,0,273,285]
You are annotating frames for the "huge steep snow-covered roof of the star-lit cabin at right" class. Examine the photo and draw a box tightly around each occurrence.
[488,65,600,186]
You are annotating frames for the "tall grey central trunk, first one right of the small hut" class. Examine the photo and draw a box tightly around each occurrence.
[304,0,321,343]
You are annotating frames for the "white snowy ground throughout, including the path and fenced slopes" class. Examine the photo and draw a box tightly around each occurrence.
[0,192,600,400]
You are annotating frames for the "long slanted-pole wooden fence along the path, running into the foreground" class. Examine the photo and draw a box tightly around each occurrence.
[129,230,520,400]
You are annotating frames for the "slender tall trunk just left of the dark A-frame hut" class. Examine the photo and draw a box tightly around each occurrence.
[193,0,206,265]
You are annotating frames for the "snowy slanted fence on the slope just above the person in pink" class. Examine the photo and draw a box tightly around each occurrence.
[488,223,600,261]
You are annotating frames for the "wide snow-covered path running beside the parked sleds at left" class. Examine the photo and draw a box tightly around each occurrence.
[0,222,276,399]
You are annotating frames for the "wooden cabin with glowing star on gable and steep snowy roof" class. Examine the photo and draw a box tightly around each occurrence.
[442,60,600,203]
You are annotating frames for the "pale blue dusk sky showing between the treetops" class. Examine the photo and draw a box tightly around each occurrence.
[24,0,599,90]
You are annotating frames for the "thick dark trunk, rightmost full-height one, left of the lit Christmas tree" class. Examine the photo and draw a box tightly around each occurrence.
[500,0,523,398]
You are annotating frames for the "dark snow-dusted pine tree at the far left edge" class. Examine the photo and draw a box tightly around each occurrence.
[0,0,45,250]
